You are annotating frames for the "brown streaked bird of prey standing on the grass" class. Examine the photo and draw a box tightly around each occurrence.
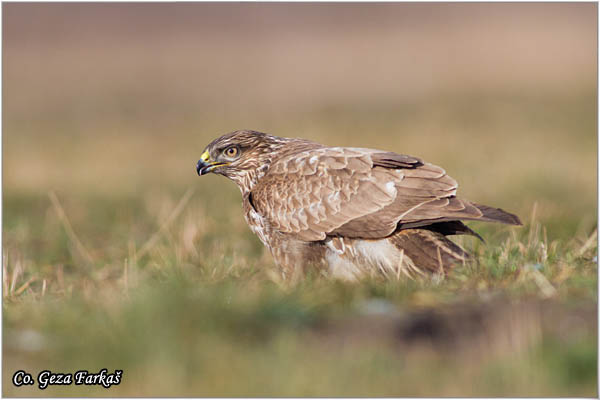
[196,130,521,280]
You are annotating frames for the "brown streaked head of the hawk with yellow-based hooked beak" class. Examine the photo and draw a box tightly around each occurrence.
[196,130,312,192]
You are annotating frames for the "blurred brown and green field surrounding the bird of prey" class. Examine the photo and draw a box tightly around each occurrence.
[2,3,598,397]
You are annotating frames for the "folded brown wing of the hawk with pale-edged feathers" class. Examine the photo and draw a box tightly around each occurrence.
[252,147,516,241]
